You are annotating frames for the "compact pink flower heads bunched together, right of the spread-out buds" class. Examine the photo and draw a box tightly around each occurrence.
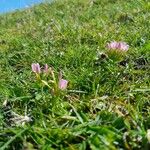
[107,41,129,52]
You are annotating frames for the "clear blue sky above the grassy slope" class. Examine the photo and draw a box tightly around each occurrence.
[0,0,43,13]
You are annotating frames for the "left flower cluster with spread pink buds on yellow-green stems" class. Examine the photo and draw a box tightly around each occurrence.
[31,63,68,91]
